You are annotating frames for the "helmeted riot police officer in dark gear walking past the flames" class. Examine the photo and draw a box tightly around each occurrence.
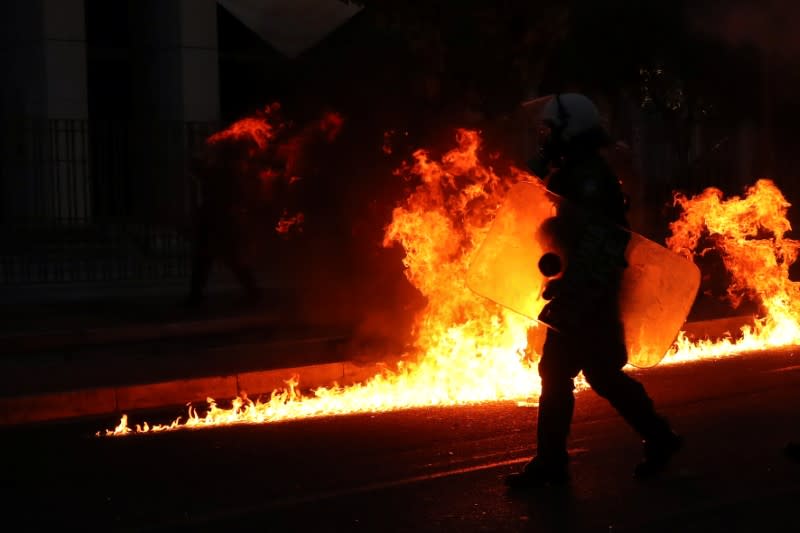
[506,94,681,489]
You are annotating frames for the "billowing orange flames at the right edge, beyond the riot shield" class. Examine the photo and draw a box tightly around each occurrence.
[667,179,800,362]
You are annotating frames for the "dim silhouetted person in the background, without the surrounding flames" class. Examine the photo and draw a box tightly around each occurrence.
[186,139,264,305]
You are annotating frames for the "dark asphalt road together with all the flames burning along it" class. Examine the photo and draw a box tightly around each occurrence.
[3,100,800,531]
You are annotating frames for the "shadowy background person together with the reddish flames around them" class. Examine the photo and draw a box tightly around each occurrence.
[188,103,343,304]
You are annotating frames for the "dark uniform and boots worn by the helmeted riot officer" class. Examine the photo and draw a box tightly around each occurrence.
[508,147,680,487]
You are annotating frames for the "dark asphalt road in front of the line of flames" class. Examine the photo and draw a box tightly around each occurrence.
[0,351,800,532]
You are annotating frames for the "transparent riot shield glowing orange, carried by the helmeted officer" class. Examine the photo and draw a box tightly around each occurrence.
[467,182,700,368]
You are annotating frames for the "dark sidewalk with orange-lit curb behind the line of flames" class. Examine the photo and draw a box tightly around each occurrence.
[0,276,748,426]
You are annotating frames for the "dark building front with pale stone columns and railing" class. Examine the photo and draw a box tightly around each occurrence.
[0,0,220,224]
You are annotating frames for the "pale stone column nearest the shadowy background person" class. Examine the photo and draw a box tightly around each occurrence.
[131,0,220,224]
